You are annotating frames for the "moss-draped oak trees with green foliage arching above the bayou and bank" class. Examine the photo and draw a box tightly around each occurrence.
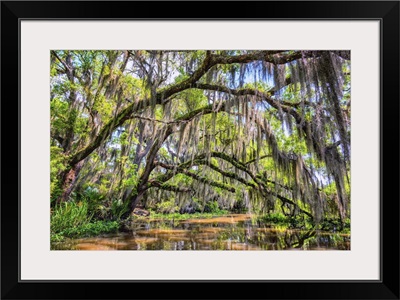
[50,50,350,221]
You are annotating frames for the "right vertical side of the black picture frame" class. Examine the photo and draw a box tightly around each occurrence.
[380,1,400,299]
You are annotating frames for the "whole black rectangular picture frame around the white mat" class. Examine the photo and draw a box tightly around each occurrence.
[1,1,400,299]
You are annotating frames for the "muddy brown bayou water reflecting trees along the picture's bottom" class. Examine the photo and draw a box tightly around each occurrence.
[51,214,350,250]
